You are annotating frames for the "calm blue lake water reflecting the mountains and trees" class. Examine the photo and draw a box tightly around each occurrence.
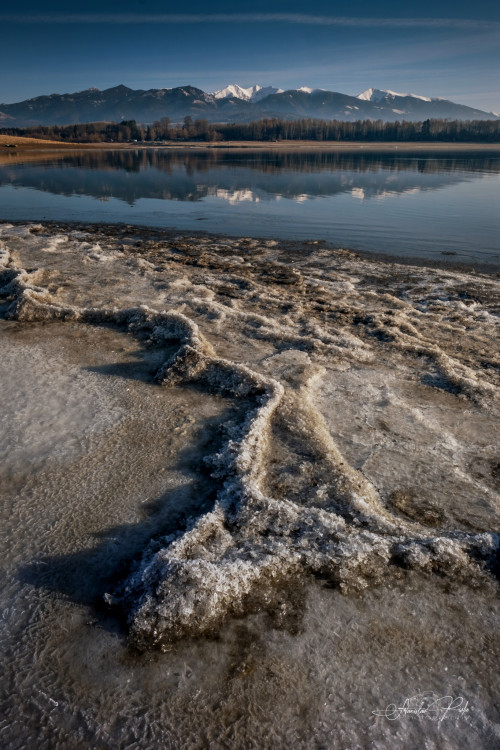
[0,150,500,266]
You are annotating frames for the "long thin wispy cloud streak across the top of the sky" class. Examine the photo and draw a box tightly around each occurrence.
[0,13,500,31]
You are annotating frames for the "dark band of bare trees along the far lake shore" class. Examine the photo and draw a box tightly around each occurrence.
[0,116,500,144]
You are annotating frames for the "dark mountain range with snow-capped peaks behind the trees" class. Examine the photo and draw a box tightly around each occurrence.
[0,84,499,128]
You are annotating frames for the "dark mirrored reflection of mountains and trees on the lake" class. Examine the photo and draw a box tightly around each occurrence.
[0,149,500,206]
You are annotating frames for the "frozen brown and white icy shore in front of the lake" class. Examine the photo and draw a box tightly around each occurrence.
[0,225,500,748]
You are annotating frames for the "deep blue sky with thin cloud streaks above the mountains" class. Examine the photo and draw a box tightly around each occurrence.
[0,0,500,112]
